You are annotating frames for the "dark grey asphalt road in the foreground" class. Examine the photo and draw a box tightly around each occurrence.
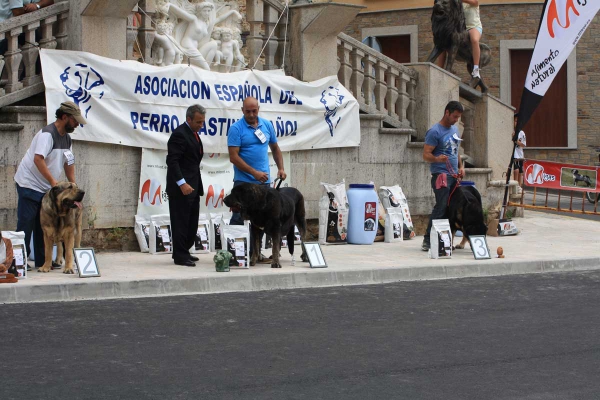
[0,272,600,400]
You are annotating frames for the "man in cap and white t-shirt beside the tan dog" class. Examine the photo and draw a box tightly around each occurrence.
[15,101,86,268]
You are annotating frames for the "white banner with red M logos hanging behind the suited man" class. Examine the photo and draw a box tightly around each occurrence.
[137,149,291,215]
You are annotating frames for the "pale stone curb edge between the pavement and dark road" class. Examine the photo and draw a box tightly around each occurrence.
[0,257,600,304]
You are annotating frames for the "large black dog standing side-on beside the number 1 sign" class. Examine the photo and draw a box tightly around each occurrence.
[223,183,308,268]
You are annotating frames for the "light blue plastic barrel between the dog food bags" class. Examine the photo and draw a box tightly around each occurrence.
[348,183,377,244]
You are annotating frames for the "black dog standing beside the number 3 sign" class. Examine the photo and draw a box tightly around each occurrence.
[448,186,487,249]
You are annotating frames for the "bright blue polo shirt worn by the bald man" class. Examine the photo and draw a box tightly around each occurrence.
[227,117,277,183]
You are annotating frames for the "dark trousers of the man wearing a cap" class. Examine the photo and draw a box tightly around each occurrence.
[17,185,46,267]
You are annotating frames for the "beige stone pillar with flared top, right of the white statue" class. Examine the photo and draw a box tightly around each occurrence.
[289,3,364,81]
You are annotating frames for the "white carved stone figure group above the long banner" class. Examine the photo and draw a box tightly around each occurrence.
[155,0,243,70]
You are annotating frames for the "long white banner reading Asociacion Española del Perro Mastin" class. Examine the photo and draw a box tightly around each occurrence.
[41,49,360,153]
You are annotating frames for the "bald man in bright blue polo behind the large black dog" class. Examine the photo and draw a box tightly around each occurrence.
[227,97,287,260]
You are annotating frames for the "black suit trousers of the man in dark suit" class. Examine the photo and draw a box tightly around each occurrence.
[167,191,200,261]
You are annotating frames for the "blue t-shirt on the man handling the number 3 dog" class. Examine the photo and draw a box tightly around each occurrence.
[425,123,461,174]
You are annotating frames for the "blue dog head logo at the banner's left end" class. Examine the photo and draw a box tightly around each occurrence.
[60,63,104,118]
